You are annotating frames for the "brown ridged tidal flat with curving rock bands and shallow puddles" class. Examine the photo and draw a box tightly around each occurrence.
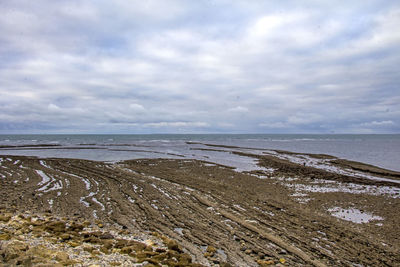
[0,150,400,266]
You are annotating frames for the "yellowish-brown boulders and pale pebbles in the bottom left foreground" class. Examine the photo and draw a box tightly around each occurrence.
[0,209,205,267]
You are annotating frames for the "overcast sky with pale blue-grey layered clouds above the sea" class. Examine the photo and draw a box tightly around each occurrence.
[0,0,400,134]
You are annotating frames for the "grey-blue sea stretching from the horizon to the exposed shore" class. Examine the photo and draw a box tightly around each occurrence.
[0,134,400,171]
